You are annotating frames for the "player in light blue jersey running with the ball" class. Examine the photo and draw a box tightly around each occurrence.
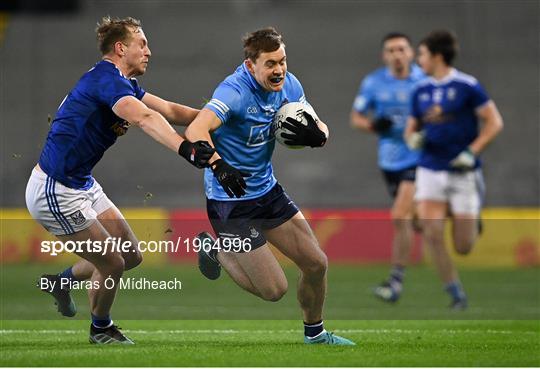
[186,27,354,345]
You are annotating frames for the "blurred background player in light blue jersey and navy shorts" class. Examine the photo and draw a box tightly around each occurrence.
[351,32,425,302]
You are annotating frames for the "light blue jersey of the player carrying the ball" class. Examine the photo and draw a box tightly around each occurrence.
[204,63,307,201]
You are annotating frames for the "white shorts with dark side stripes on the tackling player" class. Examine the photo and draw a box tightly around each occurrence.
[26,168,113,236]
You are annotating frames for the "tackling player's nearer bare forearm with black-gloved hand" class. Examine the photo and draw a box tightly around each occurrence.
[113,96,215,168]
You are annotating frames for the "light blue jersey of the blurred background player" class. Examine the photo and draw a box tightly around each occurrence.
[353,64,425,171]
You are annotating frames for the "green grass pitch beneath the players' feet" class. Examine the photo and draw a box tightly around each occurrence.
[0,265,540,366]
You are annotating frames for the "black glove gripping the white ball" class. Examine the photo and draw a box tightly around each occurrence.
[281,111,326,147]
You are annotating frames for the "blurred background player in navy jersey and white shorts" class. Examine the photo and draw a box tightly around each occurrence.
[405,31,503,309]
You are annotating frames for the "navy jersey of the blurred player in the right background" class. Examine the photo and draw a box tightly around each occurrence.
[411,69,489,170]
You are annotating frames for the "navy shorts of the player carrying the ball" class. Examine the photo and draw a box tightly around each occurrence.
[206,183,300,250]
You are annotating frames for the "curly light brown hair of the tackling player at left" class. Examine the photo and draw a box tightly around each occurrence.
[96,16,141,55]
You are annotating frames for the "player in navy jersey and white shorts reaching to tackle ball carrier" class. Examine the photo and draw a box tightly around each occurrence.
[26,17,215,344]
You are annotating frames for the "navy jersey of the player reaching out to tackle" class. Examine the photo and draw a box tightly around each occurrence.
[39,61,145,190]
